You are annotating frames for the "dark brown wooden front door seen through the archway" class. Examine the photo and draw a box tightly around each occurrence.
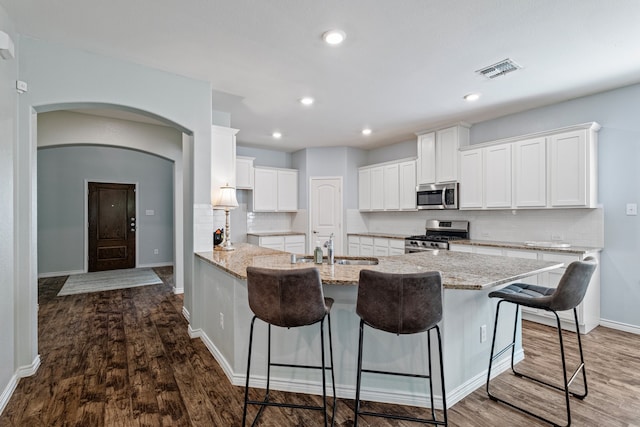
[89,182,136,271]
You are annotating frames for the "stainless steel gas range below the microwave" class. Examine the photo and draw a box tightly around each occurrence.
[404,219,469,254]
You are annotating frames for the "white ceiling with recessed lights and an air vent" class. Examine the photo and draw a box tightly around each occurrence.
[0,0,640,151]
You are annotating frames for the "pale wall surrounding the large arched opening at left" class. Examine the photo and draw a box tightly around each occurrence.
[14,37,216,382]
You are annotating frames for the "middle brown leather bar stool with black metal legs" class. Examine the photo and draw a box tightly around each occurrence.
[353,270,447,427]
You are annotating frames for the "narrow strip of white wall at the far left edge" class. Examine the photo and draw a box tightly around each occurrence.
[0,6,18,412]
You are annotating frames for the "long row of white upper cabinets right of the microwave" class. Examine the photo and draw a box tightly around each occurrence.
[460,123,600,209]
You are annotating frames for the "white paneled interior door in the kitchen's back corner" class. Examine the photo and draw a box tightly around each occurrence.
[309,177,343,255]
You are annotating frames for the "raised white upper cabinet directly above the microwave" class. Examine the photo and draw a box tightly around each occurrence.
[417,125,469,184]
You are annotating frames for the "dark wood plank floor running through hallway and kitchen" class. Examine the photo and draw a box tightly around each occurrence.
[0,269,640,427]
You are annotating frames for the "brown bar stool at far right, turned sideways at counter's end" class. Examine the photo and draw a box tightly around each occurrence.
[487,257,597,426]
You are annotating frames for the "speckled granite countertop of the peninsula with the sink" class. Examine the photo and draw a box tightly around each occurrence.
[196,243,563,290]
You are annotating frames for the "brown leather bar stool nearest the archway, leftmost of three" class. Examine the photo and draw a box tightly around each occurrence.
[242,267,336,426]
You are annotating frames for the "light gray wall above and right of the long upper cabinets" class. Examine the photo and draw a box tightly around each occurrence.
[471,85,640,328]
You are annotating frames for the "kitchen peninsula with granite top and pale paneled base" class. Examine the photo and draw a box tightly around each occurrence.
[189,244,562,407]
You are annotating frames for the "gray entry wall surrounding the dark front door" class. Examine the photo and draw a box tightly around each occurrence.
[38,146,174,275]
